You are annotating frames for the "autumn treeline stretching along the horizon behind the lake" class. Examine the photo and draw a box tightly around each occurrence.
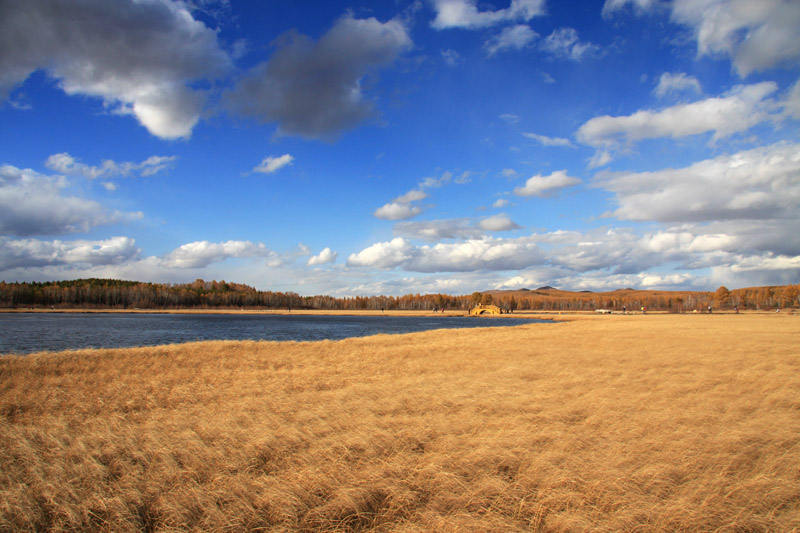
[0,279,800,313]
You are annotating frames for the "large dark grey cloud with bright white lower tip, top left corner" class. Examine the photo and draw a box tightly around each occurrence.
[0,0,230,139]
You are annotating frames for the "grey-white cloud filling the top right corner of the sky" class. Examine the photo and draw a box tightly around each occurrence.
[603,0,800,77]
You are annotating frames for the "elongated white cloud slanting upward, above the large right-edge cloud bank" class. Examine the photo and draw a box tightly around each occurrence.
[576,82,777,148]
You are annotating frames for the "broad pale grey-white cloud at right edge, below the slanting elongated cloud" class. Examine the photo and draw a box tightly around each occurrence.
[595,143,800,223]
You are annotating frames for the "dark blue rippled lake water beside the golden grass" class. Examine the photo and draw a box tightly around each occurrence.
[0,313,546,354]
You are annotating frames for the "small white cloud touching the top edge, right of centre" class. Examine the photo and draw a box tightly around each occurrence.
[431,0,544,30]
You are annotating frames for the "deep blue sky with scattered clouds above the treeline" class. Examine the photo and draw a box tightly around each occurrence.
[0,0,800,296]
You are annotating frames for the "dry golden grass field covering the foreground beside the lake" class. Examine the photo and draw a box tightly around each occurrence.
[0,315,800,531]
